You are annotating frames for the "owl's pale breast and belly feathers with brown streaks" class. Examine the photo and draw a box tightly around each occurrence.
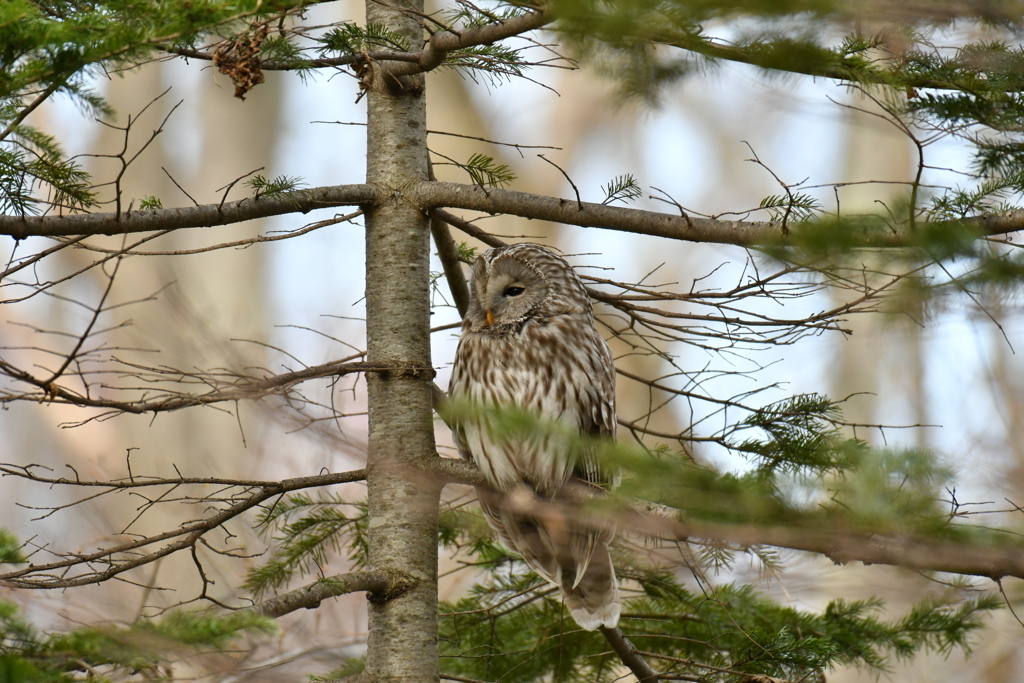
[451,314,615,496]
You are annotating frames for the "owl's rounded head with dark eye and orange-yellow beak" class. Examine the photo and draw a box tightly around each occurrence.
[466,244,590,332]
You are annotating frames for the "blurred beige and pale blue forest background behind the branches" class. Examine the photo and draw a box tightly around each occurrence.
[0,2,1024,683]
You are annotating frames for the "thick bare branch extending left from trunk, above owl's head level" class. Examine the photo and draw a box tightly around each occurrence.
[0,184,385,240]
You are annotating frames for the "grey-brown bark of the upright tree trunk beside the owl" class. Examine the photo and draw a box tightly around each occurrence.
[362,0,441,682]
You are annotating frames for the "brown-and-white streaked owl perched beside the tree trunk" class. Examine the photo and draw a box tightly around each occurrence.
[450,244,620,631]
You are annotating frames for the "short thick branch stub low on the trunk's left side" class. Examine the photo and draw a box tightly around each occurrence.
[238,569,416,618]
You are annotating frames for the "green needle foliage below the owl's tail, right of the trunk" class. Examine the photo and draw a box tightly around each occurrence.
[440,513,1000,682]
